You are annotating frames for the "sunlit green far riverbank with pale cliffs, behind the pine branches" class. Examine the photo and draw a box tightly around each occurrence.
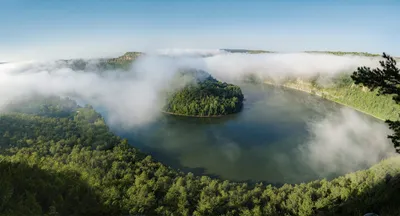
[264,80,399,121]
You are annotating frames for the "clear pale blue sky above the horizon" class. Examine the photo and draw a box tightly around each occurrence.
[0,0,400,61]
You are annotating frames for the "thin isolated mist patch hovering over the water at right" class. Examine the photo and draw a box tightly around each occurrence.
[300,108,395,176]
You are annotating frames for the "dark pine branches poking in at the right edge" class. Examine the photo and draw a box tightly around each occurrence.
[351,53,400,153]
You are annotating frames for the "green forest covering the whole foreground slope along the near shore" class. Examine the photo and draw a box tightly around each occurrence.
[0,97,400,216]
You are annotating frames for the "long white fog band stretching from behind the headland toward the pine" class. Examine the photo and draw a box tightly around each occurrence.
[205,53,379,85]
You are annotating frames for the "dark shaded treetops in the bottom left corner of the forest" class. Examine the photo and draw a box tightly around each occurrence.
[0,157,112,216]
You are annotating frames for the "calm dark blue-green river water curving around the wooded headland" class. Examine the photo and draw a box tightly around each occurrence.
[112,85,376,183]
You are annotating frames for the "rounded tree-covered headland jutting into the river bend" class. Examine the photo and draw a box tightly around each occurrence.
[164,70,244,116]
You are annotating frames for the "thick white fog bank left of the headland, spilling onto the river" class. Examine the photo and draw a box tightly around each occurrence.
[0,58,184,126]
